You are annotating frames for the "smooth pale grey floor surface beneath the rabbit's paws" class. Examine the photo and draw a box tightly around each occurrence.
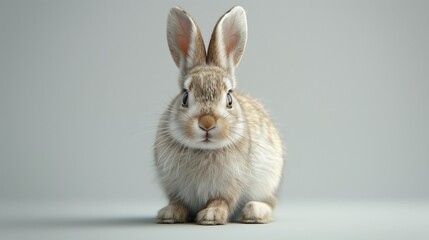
[0,201,429,240]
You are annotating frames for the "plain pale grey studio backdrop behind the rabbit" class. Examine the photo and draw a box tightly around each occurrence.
[0,0,429,238]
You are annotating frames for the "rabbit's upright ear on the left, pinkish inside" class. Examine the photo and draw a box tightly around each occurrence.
[167,7,206,74]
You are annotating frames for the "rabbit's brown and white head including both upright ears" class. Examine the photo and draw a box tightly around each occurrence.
[164,7,248,149]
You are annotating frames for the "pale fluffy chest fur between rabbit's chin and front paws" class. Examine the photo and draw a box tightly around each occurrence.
[158,143,247,210]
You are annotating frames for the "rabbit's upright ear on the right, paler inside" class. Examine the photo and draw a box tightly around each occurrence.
[207,6,247,74]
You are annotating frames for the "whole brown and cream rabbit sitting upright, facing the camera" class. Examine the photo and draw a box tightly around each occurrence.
[154,6,284,225]
